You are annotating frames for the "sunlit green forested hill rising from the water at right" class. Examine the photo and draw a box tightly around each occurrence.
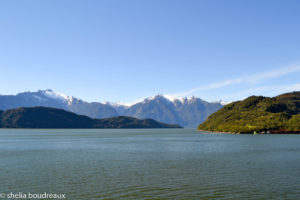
[198,92,300,133]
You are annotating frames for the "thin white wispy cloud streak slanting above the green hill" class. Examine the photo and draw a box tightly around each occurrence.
[169,65,300,97]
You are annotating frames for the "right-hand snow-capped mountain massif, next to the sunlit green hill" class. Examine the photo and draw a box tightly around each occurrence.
[121,95,223,127]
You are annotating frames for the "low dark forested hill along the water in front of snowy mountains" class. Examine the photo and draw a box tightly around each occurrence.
[0,107,181,128]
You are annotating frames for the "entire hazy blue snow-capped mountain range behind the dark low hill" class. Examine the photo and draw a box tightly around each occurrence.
[0,89,224,128]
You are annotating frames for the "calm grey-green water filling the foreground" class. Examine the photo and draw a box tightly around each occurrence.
[0,129,300,200]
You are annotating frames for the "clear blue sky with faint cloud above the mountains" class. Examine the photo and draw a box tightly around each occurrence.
[0,0,300,103]
